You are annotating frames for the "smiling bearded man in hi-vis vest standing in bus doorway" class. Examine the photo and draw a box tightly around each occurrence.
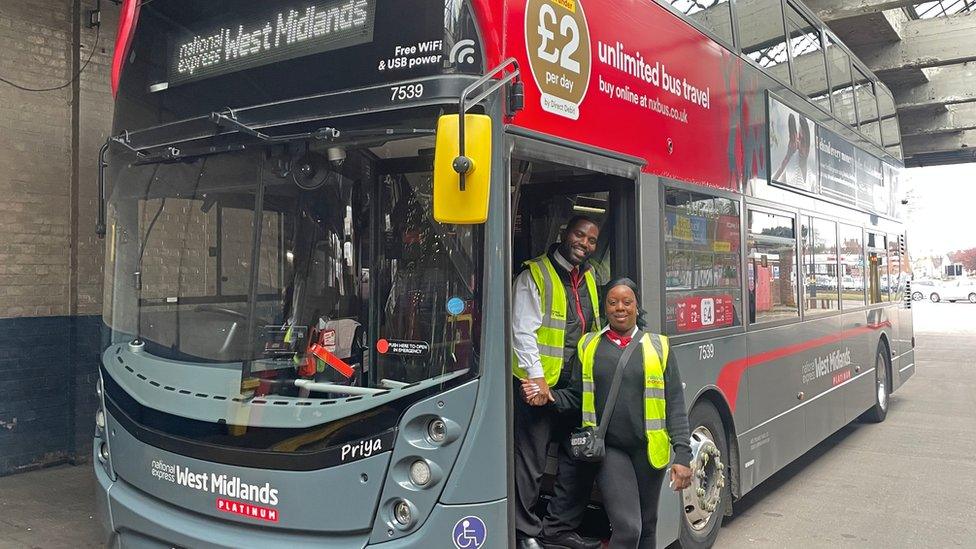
[512,216,600,549]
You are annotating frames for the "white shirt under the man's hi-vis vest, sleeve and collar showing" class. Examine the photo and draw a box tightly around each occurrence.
[512,250,585,378]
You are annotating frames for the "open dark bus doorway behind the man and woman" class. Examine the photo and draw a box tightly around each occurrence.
[508,136,640,535]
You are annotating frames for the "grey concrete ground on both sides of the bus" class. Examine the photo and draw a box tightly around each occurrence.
[0,302,976,549]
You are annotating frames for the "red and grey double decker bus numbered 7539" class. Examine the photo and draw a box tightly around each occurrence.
[94,0,914,549]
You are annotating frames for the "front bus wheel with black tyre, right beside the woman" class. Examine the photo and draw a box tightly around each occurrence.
[679,401,732,549]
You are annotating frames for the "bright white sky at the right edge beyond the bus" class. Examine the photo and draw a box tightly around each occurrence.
[897,163,976,257]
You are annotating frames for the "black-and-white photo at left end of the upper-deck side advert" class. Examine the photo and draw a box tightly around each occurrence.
[769,97,820,192]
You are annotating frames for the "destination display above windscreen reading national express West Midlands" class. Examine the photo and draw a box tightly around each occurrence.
[168,0,376,86]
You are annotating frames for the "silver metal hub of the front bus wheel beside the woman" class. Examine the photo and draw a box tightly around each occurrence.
[681,427,725,531]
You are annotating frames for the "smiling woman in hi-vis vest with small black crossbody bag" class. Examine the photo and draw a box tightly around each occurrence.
[523,278,692,549]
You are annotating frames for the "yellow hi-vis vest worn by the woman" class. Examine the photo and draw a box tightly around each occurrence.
[579,332,671,469]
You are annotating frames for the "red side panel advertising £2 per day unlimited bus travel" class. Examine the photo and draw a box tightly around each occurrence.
[476,0,743,190]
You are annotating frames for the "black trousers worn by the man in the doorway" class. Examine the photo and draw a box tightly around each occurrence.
[513,379,593,538]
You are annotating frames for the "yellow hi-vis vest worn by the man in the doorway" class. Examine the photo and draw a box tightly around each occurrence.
[512,255,600,387]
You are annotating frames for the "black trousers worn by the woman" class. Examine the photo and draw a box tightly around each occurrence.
[596,446,667,549]
